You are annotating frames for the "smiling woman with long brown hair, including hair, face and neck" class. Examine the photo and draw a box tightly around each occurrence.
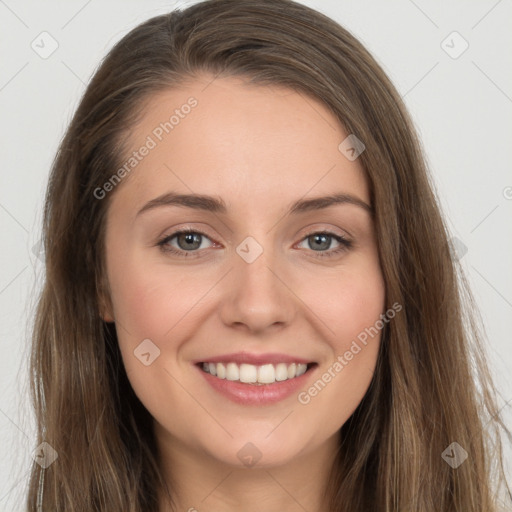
[28,0,510,512]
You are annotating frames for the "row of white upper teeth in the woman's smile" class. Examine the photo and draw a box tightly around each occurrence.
[203,363,307,384]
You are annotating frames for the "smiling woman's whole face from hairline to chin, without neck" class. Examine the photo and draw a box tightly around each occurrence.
[103,74,385,467]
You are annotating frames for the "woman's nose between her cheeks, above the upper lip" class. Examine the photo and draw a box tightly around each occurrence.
[220,241,299,333]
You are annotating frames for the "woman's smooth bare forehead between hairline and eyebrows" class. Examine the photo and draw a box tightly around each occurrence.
[110,77,369,217]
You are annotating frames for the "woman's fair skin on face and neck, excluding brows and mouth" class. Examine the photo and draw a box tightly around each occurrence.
[102,76,385,512]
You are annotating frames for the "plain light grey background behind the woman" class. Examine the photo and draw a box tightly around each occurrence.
[0,0,512,512]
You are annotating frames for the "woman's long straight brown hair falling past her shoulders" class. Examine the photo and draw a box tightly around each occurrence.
[27,0,510,512]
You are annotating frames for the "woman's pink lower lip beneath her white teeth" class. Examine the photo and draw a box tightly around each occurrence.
[196,364,317,405]
